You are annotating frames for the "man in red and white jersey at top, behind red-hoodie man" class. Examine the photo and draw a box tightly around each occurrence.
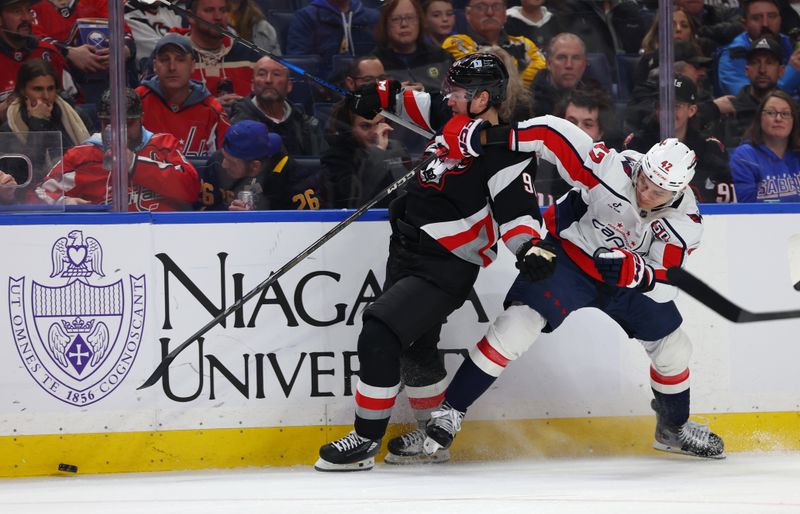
[173,0,261,109]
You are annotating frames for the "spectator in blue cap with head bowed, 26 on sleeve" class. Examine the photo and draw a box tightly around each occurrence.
[196,120,320,211]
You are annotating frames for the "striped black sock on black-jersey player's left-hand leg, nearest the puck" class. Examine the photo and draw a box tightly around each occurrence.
[355,318,402,440]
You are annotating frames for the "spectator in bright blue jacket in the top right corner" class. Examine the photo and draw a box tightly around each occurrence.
[718,0,800,95]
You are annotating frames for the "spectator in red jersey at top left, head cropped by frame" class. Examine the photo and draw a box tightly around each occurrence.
[31,0,137,103]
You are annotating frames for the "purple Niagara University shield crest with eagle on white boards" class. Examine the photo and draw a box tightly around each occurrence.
[8,230,146,406]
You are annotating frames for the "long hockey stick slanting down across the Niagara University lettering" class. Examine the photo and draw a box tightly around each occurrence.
[137,149,446,389]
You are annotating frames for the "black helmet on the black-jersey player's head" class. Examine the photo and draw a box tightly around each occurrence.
[446,53,508,106]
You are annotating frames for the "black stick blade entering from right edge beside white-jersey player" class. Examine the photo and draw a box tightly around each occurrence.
[667,266,800,323]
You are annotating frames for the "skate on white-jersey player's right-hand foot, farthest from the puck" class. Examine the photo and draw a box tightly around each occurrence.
[650,400,725,459]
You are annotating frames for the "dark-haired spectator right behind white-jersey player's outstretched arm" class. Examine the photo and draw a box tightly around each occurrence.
[536,89,619,207]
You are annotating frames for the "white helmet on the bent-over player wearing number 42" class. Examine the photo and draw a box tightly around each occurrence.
[633,137,697,193]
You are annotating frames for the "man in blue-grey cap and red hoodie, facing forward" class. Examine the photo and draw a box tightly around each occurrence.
[136,32,230,158]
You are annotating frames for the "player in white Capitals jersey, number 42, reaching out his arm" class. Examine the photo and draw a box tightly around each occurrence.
[424,116,724,458]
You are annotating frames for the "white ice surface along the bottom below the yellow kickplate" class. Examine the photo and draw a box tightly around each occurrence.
[0,452,800,514]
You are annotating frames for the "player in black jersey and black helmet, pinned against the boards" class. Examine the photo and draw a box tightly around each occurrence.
[315,54,555,471]
